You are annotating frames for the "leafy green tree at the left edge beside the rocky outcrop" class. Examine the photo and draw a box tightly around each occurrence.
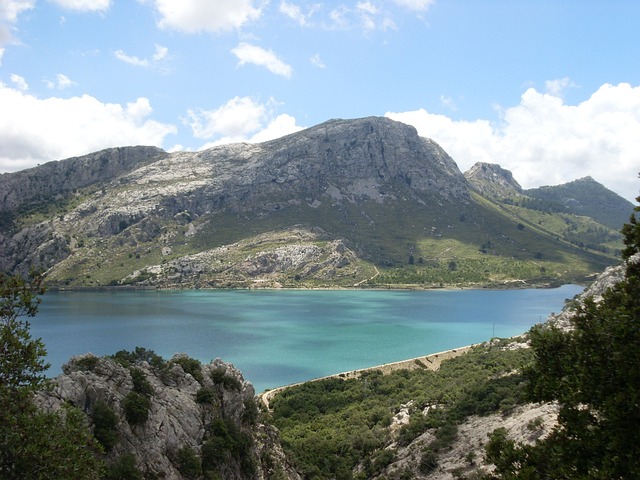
[0,274,102,480]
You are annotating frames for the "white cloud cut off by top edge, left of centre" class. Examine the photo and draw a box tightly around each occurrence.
[154,0,262,33]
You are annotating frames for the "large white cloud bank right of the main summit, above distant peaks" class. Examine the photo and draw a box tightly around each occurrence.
[386,83,640,200]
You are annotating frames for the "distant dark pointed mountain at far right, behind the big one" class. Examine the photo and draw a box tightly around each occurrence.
[524,177,633,230]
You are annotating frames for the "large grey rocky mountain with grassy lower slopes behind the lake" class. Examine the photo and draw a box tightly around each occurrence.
[0,117,619,288]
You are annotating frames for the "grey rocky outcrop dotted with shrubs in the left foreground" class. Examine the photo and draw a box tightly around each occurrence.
[38,354,300,480]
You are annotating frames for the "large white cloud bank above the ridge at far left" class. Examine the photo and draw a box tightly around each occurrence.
[0,83,177,171]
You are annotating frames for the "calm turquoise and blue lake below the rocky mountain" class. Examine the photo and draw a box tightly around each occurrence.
[31,285,582,392]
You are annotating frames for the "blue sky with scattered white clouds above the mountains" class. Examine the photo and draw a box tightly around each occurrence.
[0,0,640,203]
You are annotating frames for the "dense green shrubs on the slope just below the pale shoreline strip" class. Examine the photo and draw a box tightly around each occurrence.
[272,343,531,479]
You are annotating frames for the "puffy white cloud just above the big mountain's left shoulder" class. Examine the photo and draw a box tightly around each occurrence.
[185,97,302,148]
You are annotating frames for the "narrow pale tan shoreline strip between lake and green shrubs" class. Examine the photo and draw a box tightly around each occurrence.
[257,343,480,410]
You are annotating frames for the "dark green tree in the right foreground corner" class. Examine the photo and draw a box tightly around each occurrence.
[487,182,640,479]
